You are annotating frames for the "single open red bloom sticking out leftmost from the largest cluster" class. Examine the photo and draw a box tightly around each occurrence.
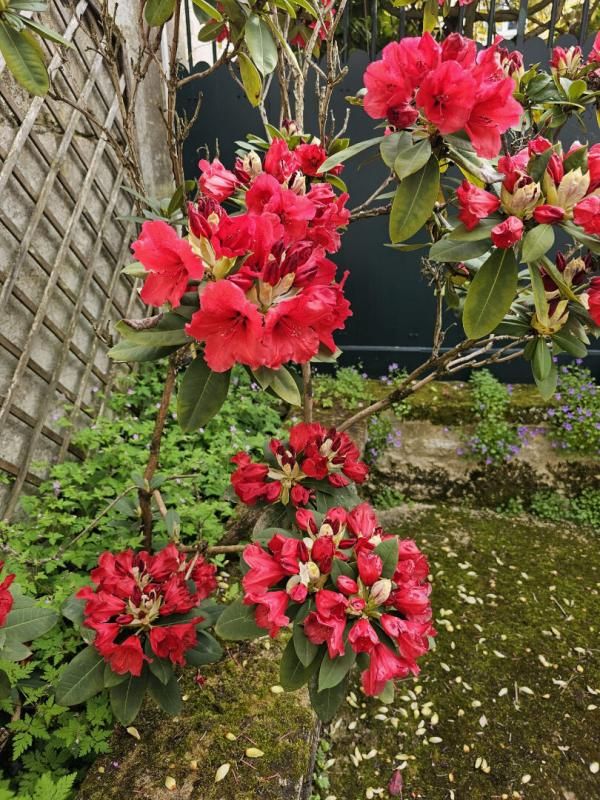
[131,220,204,308]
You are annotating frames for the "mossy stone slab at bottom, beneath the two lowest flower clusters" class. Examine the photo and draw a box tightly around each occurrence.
[79,643,315,800]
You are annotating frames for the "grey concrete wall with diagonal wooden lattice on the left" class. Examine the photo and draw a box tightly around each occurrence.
[0,0,170,518]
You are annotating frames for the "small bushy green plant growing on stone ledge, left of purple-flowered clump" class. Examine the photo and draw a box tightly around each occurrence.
[466,370,519,464]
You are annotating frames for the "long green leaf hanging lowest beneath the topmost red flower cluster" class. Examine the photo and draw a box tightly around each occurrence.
[390,156,440,243]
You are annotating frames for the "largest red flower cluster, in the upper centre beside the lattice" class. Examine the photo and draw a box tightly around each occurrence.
[133,138,350,372]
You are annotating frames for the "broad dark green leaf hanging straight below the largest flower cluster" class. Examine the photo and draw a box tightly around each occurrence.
[177,356,231,433]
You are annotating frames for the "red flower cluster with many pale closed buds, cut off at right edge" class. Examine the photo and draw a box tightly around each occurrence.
[457,136,600,248]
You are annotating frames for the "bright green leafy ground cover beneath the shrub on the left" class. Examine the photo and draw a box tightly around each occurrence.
[0,364,283,800]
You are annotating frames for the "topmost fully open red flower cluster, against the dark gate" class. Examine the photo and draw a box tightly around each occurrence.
[364,33,523,158]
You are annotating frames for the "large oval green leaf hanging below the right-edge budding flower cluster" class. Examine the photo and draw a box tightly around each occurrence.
[463,248,518,339]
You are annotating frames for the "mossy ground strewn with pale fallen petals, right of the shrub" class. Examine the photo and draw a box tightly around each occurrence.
[323,506,600,800]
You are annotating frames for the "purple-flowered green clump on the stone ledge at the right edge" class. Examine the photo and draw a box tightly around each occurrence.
[546,364,600,456]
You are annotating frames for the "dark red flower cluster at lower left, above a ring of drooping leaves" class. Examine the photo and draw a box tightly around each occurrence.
[76,544,217,676]
